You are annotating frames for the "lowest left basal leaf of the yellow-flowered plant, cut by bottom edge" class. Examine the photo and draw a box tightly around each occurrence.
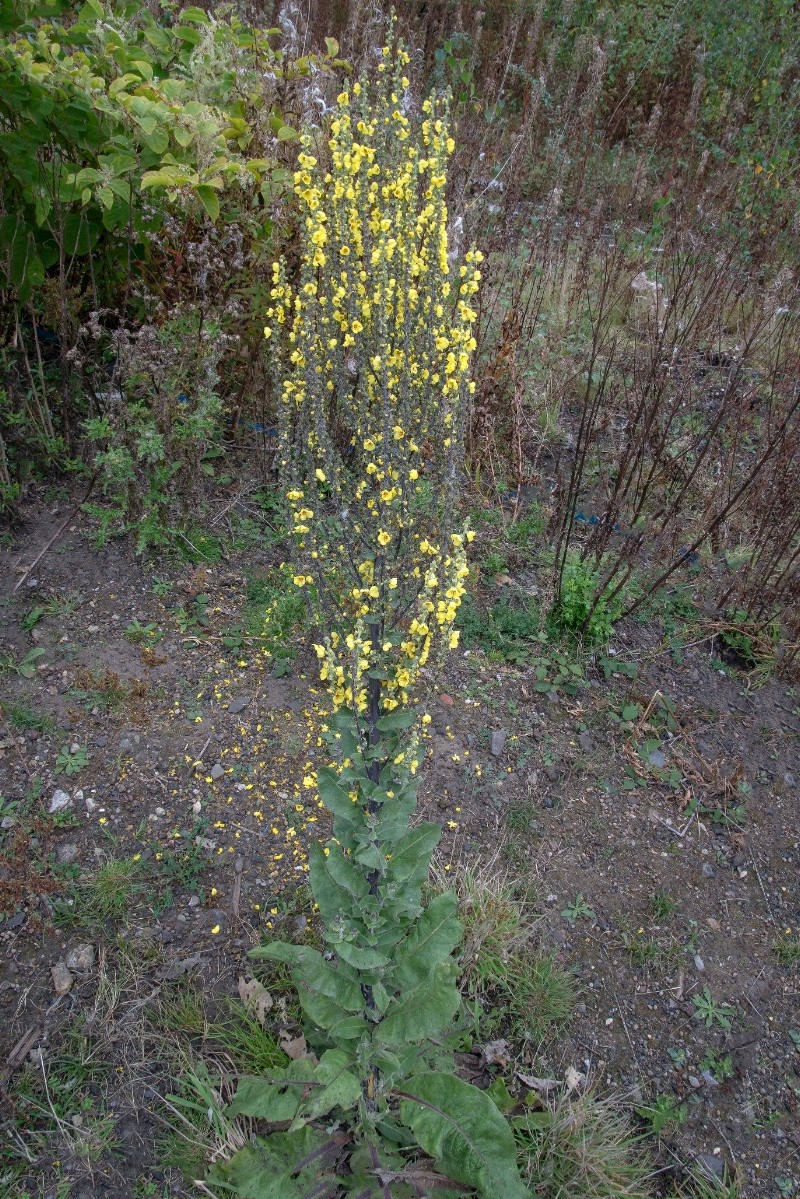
[206,1125,335,1199]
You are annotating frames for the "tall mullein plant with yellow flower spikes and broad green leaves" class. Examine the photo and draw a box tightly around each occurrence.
[212,47,529,1199]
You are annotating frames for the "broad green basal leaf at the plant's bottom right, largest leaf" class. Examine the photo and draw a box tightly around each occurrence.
[397,1071,530,1199]
